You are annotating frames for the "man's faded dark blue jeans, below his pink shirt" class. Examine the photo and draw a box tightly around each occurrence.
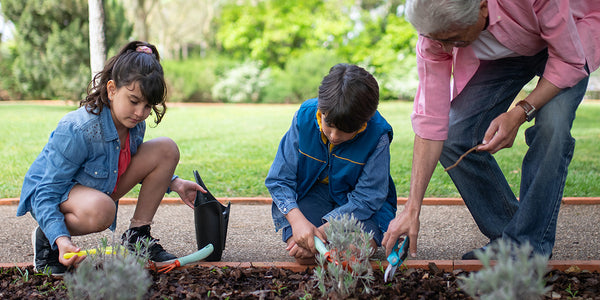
[440,51,589,255]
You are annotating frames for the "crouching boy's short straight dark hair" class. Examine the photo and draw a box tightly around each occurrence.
[318,64,379,133]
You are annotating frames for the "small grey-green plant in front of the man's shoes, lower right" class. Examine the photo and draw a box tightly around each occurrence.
[459,239,550,300]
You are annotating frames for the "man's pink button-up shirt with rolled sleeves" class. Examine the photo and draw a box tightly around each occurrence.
[411,0,600,140]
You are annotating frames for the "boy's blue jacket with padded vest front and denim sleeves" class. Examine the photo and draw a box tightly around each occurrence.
[265,98,397,232]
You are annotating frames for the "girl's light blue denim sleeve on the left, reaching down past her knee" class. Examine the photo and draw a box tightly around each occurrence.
[31,124,88,248]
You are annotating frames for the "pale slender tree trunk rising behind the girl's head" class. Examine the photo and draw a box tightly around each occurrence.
[88,0,106,79]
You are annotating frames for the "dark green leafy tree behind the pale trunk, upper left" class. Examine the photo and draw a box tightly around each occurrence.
[2,0,131,100]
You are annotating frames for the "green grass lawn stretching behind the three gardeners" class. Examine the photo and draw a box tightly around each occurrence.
[0,101,600,198]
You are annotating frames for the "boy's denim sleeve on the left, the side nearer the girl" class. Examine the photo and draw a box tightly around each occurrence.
[265,114,298,215]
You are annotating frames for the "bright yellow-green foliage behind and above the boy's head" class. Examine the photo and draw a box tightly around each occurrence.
[217,0,417,101]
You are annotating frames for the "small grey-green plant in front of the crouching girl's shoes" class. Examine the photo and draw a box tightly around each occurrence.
[64,239,152,299]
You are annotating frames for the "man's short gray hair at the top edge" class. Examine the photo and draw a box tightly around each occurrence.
[405,0,481,34]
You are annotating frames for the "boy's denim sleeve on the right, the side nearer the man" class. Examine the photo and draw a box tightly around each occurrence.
[323,134,390,221]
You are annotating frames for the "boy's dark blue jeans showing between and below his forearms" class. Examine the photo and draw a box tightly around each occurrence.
[281,183,383,246]
